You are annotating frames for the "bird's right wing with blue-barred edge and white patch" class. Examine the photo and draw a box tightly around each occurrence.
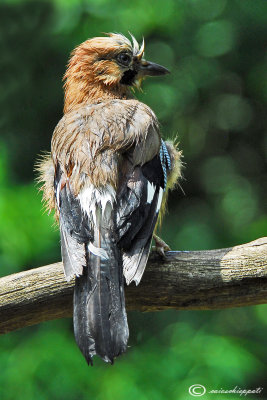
[117,141,171,285]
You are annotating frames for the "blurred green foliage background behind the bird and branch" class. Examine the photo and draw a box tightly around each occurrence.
[0,0,267,400]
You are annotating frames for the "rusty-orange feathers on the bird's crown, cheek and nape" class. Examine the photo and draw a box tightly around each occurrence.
[64,35,136,113]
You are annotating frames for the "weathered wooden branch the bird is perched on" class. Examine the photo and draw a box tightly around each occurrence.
[0,238,267,333]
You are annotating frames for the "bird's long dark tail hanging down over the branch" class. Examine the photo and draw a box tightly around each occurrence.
[73,208,129,365]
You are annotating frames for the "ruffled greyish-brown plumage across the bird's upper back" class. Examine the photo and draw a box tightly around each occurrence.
[52,99,160,195]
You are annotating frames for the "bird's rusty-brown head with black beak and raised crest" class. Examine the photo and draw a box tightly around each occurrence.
[64,33,169,112]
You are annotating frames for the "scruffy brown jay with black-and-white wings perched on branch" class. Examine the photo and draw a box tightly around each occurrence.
[39,34,181,364]
